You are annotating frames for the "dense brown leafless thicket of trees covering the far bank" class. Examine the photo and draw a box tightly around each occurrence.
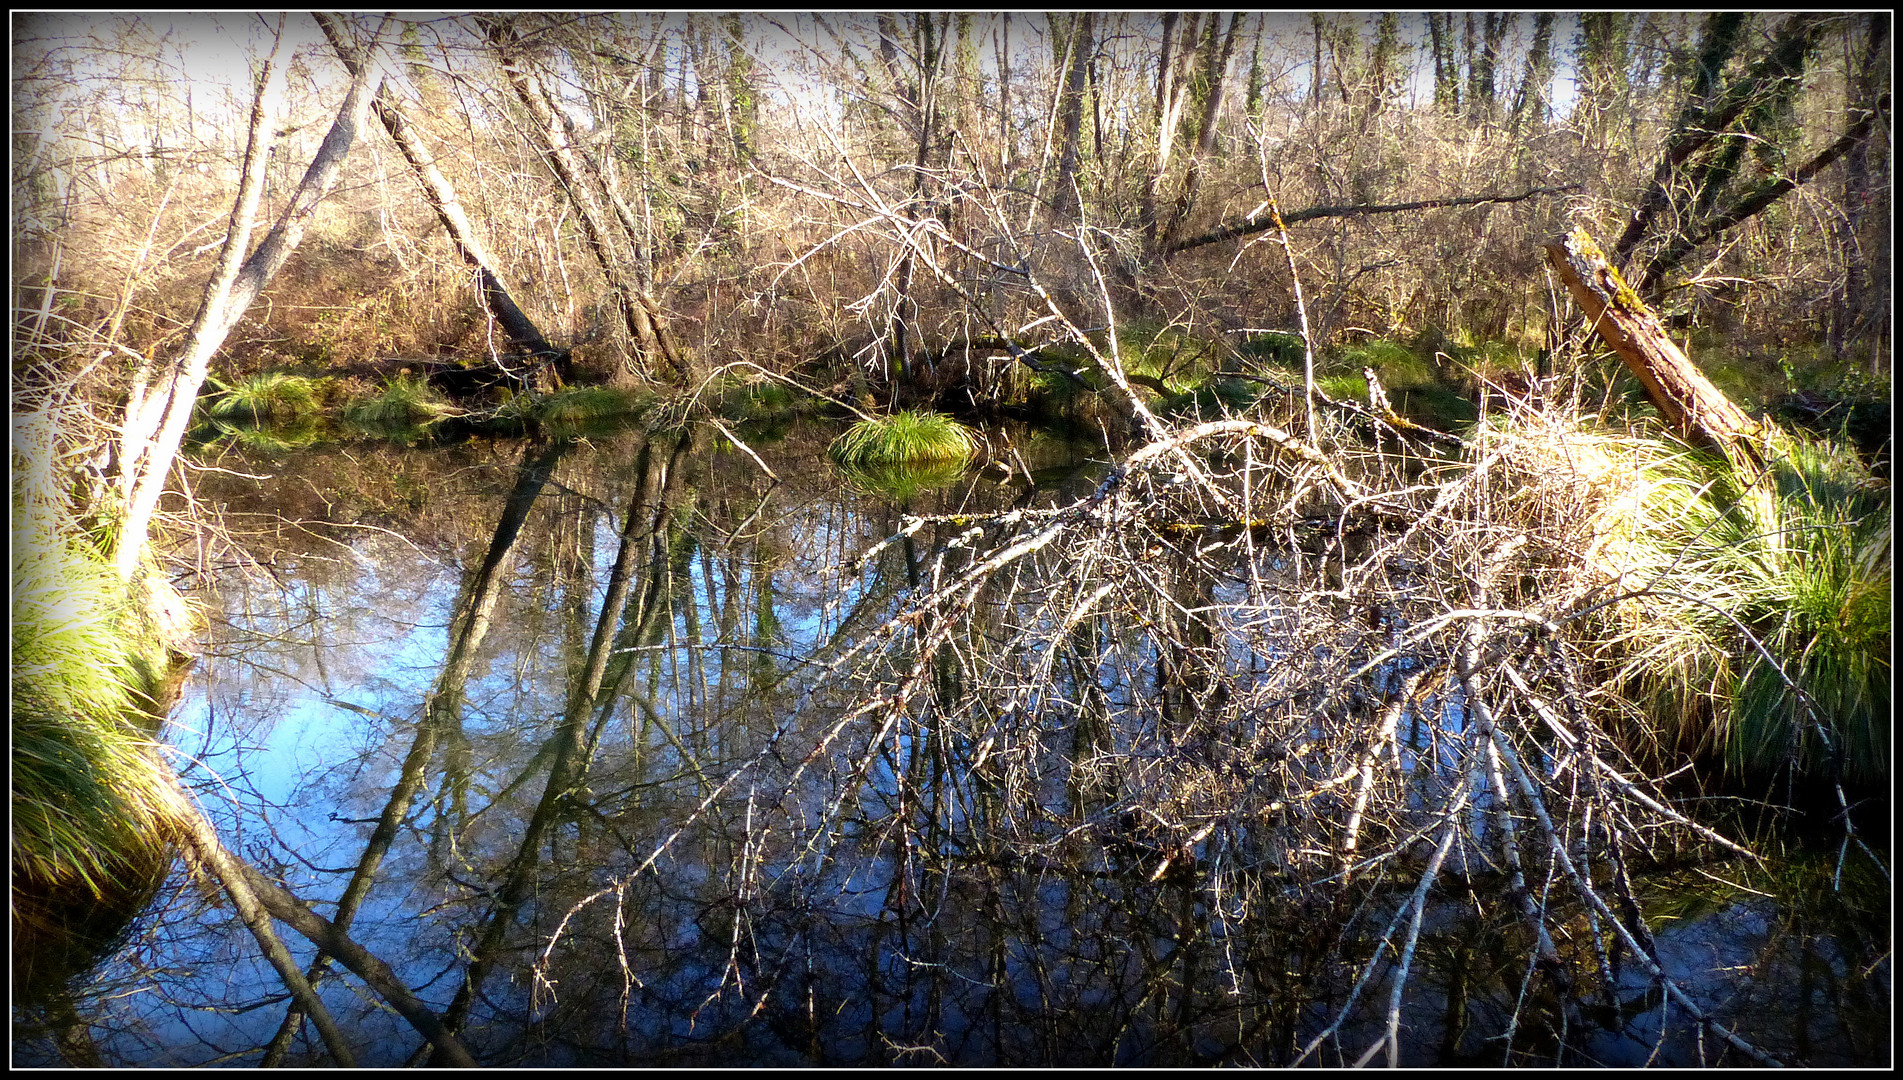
[11,13,1890,408]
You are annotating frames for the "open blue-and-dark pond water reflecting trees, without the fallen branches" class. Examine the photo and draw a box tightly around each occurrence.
[13,418,1892,1067]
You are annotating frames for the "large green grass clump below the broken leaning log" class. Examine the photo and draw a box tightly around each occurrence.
[1602,427,1892,783]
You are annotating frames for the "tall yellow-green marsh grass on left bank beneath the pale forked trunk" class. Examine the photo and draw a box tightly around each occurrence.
[8,403,185,1000]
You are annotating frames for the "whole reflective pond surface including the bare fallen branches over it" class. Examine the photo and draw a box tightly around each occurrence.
[15,424,1888,1065]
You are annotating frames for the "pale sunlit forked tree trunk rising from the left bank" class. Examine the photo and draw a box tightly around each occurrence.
[114,19,388,582]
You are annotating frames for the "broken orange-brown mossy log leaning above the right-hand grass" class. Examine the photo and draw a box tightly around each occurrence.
[1545,228,1768,464]
